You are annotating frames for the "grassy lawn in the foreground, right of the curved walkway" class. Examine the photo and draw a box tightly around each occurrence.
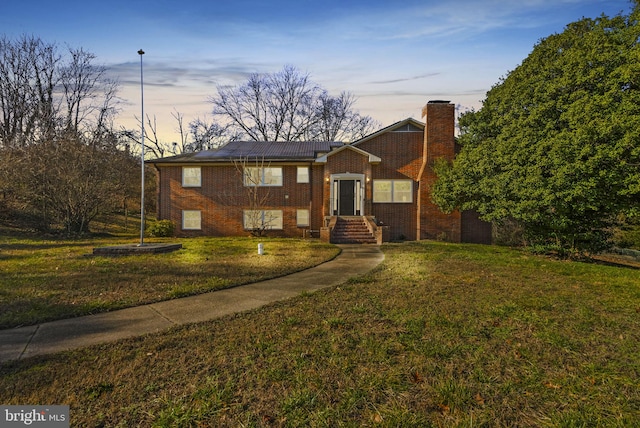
[0,242,640,427]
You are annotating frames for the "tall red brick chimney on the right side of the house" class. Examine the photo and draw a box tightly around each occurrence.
[417,100,461,242]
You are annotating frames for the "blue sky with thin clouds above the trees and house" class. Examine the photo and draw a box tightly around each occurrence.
[0,0,632,142]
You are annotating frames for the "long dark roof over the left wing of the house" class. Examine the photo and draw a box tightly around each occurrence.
[149,141,344,163]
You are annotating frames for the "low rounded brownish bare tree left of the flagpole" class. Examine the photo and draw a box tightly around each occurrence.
[7,136,138,234]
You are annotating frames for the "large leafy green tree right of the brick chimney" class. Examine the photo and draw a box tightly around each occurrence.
[433,4,640,253]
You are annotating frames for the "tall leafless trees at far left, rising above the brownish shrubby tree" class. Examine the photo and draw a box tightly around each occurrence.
[0,36,118,147]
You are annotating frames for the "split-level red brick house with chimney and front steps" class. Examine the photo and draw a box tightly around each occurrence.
[148,101,491,243]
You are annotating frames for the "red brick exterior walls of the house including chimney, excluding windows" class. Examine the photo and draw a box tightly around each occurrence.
[158,103,468,242]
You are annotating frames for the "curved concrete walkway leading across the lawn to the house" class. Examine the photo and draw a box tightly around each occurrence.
[0,245,384,362]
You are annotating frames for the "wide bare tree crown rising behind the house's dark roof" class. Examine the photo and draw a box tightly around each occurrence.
[210,66,375,141]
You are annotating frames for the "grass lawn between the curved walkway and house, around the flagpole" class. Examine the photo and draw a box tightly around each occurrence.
[0,236,339,328]
